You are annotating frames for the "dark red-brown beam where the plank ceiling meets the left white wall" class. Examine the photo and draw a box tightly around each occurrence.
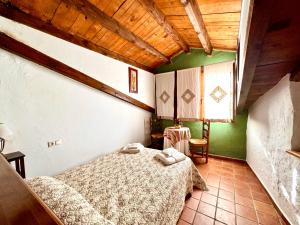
[0,1,153,72]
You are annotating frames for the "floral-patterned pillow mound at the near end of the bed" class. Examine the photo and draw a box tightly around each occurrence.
[27,176,113,225]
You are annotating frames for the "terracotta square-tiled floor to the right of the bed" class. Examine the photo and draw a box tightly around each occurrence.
[177,158,285,225]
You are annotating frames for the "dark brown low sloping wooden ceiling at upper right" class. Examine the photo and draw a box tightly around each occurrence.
[239,0,300,109]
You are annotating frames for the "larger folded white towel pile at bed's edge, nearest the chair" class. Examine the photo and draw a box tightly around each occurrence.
[154,148,186,166]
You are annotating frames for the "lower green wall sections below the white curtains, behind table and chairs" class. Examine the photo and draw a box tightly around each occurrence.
[160,112,248,159]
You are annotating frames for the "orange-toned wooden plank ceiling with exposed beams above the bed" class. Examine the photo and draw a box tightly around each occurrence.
[0,0,241,71]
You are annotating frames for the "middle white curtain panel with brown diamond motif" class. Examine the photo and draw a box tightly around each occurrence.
[177,67,201,120]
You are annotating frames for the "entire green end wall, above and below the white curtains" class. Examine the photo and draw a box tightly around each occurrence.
[154,49,248,159]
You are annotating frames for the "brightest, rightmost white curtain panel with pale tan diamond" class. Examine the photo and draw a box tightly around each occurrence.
[204,62,233,121]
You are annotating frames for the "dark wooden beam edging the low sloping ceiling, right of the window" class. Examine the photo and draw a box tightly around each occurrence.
[238,0,277,112]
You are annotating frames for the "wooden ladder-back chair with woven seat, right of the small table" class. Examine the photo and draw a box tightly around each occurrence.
[189,121,210,163]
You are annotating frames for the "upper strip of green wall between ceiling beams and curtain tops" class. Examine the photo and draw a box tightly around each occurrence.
[154,49,236,73]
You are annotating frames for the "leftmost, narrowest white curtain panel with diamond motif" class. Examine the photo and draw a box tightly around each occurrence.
[155,72,175,119]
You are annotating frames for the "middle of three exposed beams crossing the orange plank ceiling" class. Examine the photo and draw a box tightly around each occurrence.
[138,0,190,52]
